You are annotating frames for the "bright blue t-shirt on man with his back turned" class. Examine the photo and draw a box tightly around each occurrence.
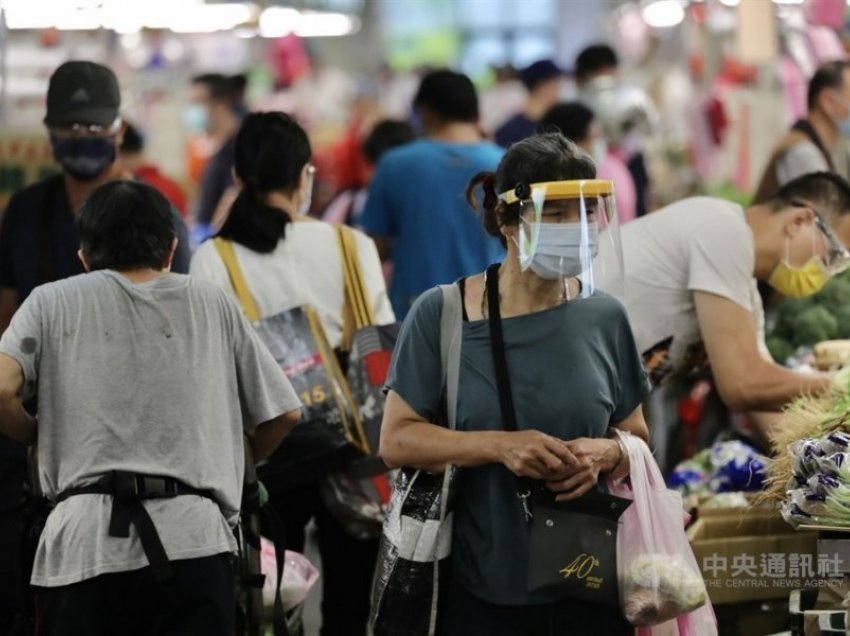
[361,139,504,320]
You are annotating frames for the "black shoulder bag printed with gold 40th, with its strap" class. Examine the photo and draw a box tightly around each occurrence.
[485,264,631,608]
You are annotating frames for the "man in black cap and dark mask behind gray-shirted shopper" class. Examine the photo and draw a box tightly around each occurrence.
[0,61,189,633]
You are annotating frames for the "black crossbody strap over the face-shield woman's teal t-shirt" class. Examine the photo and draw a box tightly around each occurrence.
[484,263,534,521]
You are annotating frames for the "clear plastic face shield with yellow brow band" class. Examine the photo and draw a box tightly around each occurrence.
[499,179,623,298]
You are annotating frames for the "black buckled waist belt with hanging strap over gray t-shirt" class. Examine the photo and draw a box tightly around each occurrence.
[56,471,215,581]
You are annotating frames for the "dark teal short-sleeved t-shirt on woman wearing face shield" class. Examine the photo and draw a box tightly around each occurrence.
[387,289,650,605]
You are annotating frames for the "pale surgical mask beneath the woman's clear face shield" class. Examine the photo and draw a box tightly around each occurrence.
[526,221,599,280]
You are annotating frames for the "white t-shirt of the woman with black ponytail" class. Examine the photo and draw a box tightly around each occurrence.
[189,221,395,347]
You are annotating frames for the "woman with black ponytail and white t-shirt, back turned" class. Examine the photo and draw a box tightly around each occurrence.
[190,112,395,636]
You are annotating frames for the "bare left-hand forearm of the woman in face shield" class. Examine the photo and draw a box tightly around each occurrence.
[380,422,506,472]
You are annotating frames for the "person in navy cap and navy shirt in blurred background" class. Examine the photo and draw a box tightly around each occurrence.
[495,60,564,148]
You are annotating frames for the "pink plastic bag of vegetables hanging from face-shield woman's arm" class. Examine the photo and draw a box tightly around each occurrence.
[609,433,717,636]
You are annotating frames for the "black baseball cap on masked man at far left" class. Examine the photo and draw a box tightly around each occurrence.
[44,61,121,126]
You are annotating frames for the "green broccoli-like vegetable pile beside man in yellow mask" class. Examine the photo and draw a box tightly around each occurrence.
[766,270,850,364]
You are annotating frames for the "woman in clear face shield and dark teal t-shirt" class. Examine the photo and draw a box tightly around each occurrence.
[381,133,649,636]
